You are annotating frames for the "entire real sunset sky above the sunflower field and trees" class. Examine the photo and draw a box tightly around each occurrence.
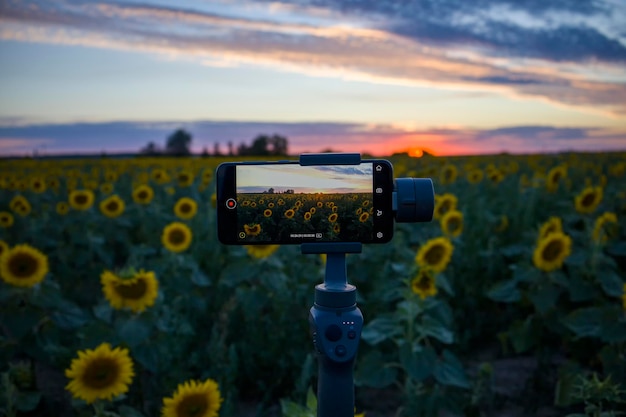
[0,0,626,156]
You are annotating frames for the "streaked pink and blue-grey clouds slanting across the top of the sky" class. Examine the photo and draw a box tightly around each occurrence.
[0,0,626,117]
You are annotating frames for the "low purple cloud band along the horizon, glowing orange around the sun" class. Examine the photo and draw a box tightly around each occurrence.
[0,120,626,156]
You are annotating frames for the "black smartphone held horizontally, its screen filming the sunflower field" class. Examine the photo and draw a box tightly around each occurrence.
[216,159,394,245]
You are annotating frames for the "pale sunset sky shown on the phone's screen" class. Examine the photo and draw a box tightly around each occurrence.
[236,163,373,194]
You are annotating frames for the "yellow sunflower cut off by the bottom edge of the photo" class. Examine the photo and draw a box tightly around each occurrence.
[161,379,224,417]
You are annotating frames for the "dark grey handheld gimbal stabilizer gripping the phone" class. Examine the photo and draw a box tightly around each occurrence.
[300,154,435,417]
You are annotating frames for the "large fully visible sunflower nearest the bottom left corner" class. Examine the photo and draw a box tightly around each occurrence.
[65,343,135,404]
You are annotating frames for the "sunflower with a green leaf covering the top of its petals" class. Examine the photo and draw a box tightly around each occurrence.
[100,270,159,313]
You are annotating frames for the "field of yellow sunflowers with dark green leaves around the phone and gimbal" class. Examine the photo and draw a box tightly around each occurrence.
[0,153,626,417]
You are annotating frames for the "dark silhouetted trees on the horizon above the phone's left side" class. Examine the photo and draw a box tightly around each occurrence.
[140,129,289,156]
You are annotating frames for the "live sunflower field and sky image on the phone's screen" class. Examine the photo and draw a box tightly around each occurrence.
[236,163,374,243]
